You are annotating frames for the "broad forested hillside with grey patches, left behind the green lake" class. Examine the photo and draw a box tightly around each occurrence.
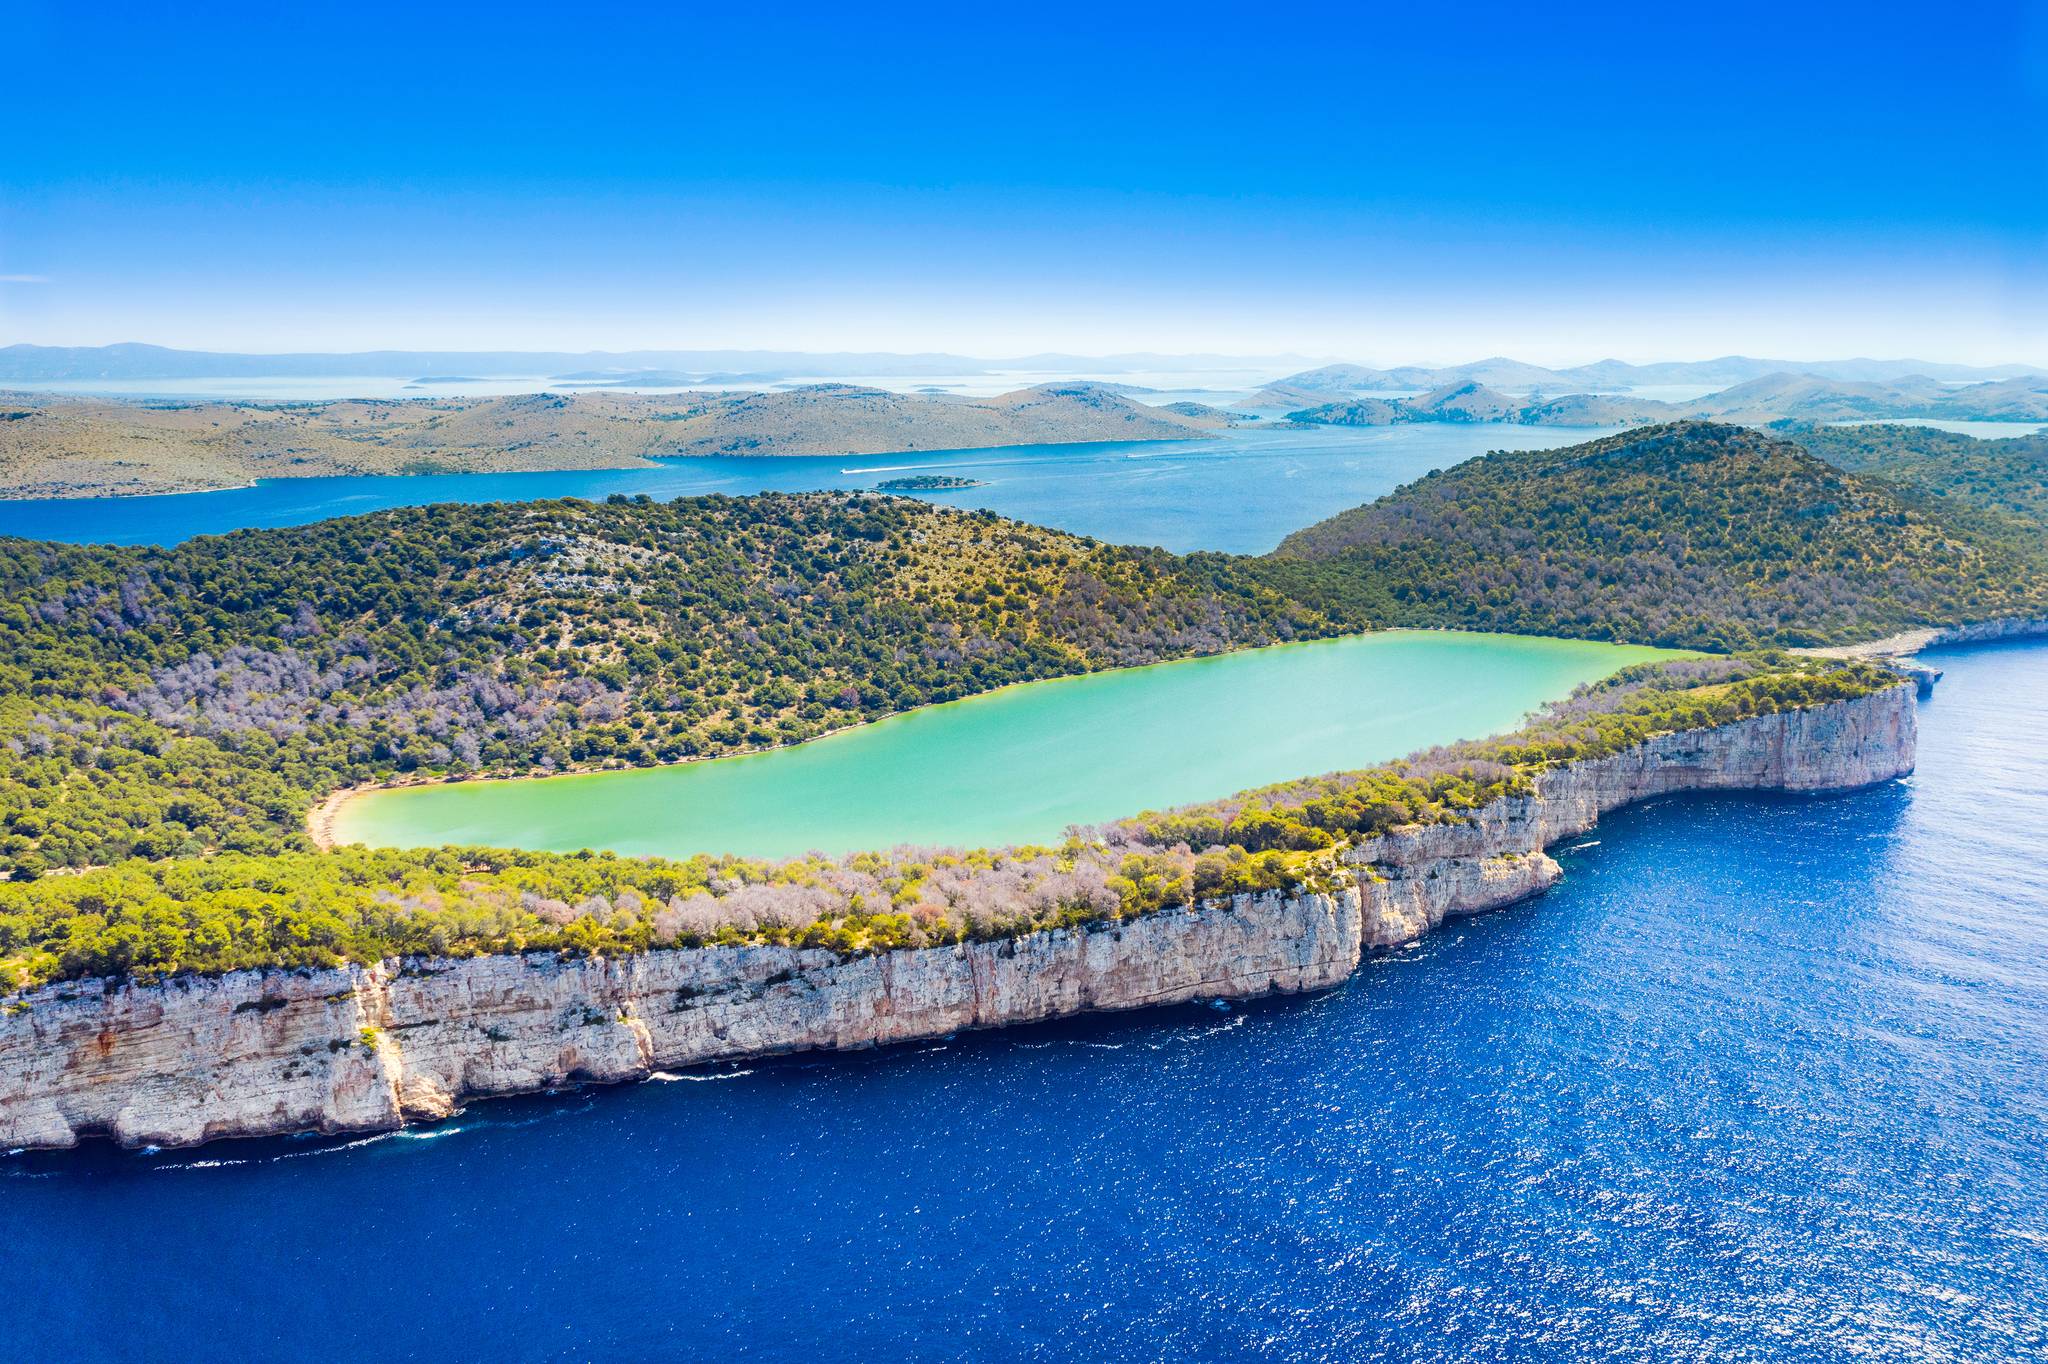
[0,494,1333,875]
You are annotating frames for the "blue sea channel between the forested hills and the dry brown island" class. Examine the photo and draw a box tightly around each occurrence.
[0,422,1612,553]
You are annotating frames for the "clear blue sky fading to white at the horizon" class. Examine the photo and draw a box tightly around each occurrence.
[0,0,2048,365]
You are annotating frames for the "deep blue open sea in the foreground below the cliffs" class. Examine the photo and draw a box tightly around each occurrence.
[0,645,2048,1364]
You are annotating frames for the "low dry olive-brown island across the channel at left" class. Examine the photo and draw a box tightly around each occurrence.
[0,383,1241,498]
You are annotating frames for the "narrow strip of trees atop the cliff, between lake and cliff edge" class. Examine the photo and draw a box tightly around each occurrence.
[0,655,1896,987]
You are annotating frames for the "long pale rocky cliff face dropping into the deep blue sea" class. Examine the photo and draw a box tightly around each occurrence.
[0,684,1915,1147]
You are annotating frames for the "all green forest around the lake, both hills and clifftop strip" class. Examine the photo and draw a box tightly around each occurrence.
[0,424,1998,985]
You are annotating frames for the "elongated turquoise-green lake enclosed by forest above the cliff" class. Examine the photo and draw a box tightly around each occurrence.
[336,631,1665,856]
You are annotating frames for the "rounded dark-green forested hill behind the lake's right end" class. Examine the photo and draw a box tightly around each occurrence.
[1264,422,2048,649]
